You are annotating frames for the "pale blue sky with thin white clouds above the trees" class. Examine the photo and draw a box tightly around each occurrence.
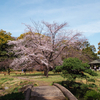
[0,0,100,49]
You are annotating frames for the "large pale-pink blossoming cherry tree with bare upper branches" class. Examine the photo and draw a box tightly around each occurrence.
[8,22,84,77]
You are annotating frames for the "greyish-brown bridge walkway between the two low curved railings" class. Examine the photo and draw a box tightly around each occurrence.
[30,86,66,100]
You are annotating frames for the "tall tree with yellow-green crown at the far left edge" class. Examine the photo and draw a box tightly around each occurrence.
[0,29,14,70]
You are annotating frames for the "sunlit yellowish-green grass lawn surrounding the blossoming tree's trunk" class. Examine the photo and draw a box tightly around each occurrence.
[0,71,100,99]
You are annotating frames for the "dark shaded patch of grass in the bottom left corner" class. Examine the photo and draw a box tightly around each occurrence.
[0,92,25,100]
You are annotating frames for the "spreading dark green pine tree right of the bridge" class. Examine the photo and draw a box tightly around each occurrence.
[55,58,97,81]
